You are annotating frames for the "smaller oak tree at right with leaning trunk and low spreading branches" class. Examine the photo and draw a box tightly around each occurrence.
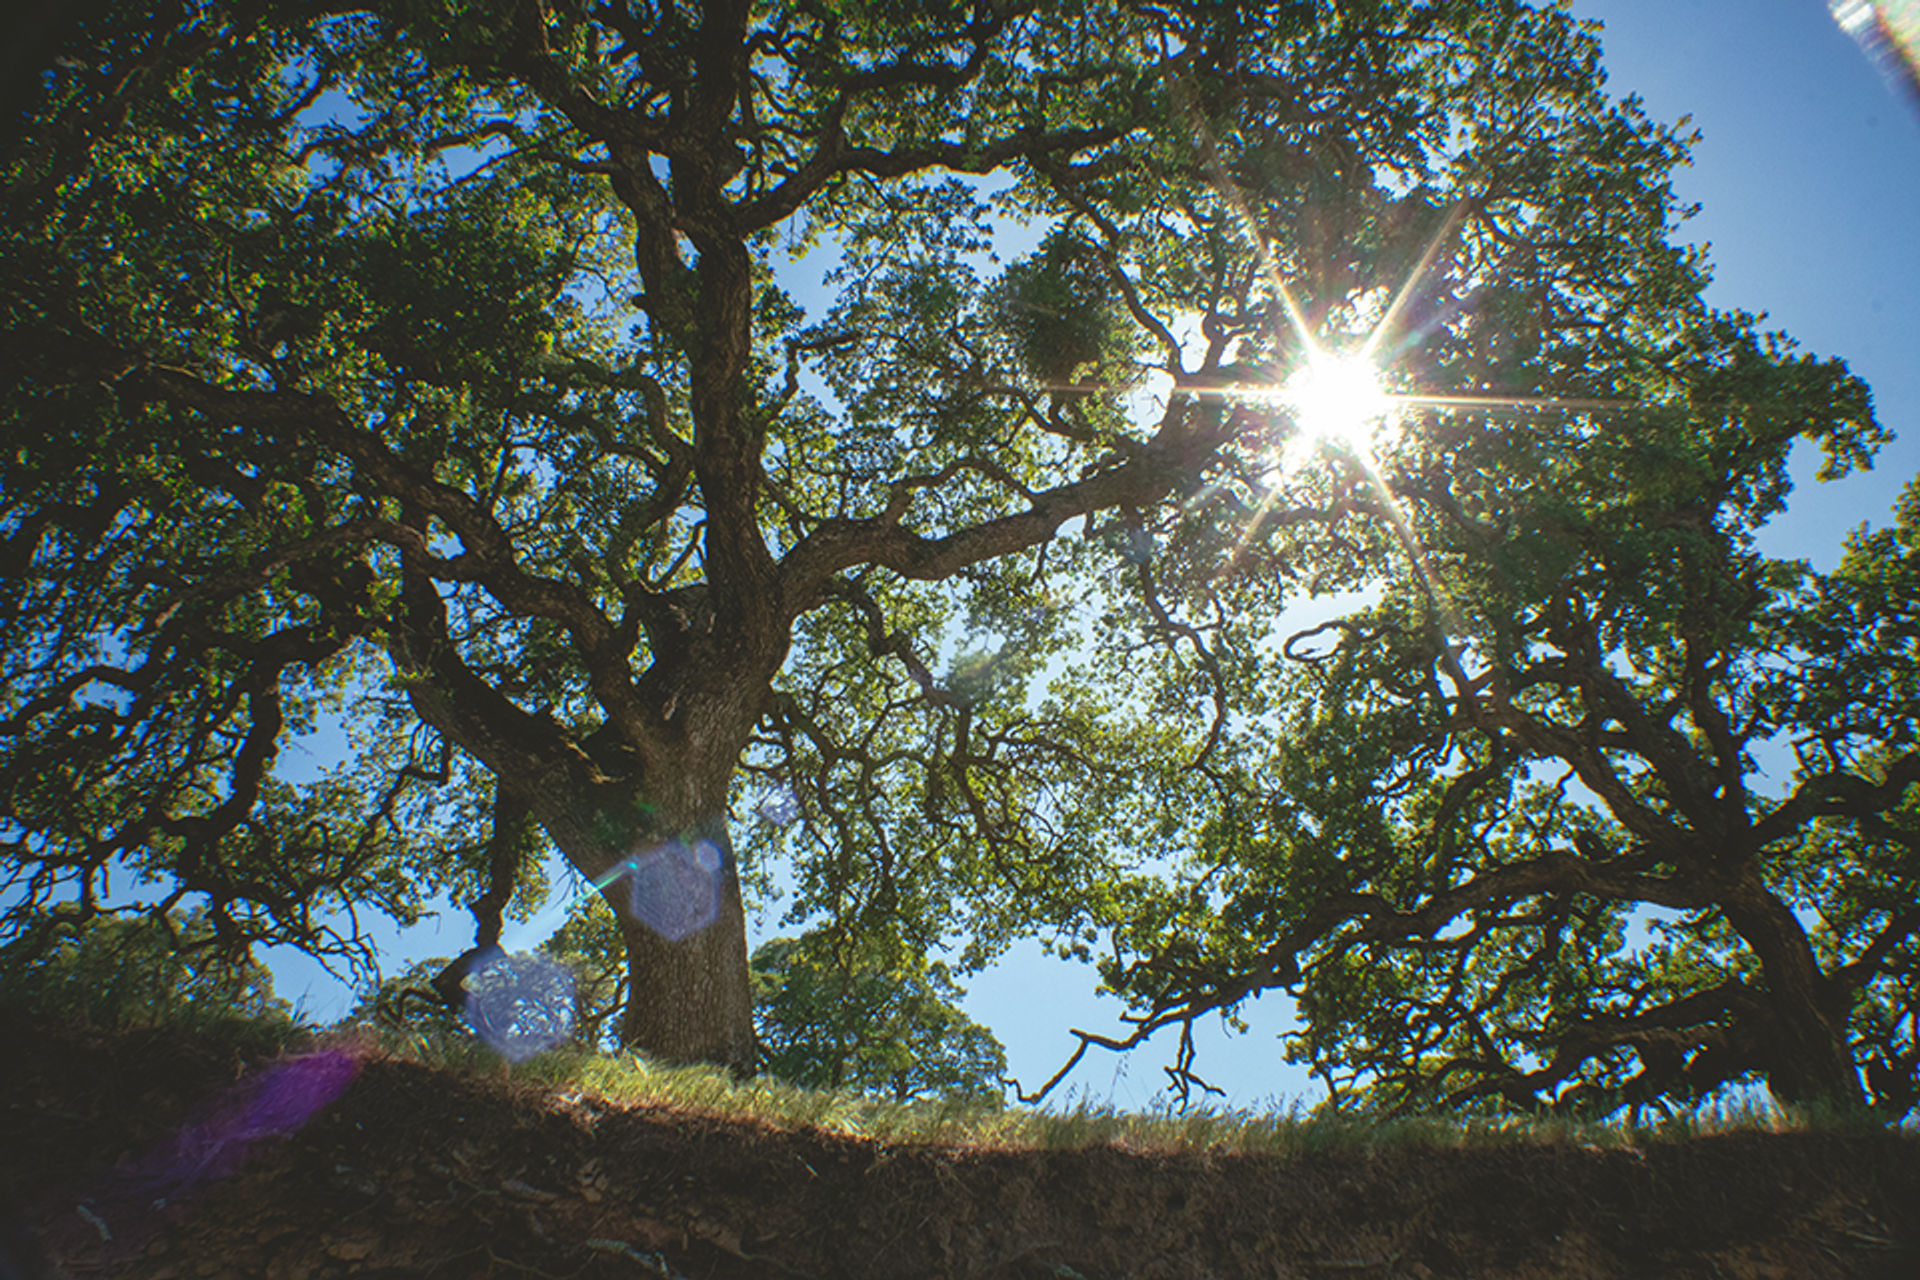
[1081,333,1920,1119]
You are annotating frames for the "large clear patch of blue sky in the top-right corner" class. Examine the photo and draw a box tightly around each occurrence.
[1574,0,1920,568]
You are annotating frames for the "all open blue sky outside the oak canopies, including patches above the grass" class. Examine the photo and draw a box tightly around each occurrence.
[273,0,1920,1107]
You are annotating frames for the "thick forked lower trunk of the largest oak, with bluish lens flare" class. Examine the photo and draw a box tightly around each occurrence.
[394,498,785,1075]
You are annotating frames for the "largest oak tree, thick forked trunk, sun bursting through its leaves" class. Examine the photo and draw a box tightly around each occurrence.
[0,0,1878,1120]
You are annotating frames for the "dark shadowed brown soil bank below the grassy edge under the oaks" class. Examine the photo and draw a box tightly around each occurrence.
[0,1017,1920,1280]
